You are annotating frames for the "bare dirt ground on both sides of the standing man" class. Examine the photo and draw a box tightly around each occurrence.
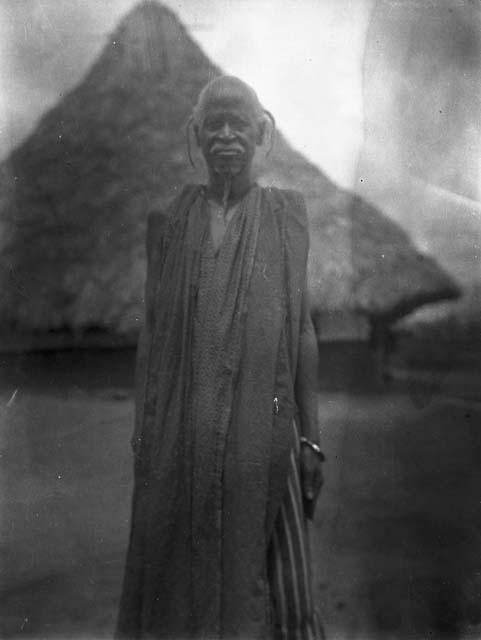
[0,353,481,640]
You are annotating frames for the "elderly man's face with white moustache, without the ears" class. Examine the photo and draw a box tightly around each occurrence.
[196,98,263,176]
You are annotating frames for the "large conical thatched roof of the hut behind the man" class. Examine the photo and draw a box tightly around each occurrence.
[0,2,457,340]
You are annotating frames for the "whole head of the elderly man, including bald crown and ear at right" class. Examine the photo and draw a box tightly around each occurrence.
[188,76,273,176]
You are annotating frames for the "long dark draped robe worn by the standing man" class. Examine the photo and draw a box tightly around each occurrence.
[117,185,308,639]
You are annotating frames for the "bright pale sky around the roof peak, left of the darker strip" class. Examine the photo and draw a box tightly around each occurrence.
[0,0,374,186]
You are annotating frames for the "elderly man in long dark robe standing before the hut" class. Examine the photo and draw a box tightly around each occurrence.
[117,76,323,640]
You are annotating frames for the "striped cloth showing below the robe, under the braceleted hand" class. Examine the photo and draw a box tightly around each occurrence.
[267,423,324,640]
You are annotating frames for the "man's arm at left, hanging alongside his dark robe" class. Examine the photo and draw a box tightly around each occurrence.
[131,212,167,455]
